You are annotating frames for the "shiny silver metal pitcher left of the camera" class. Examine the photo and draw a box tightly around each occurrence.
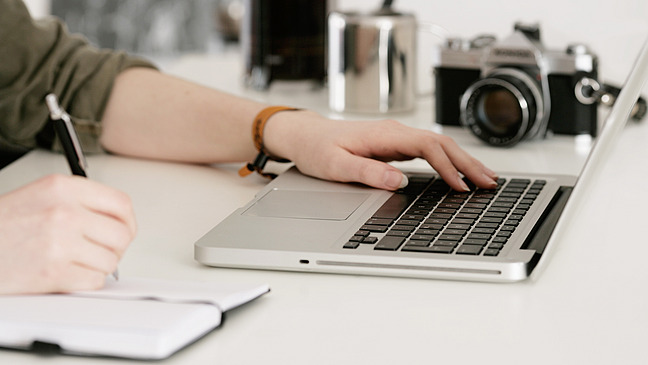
[328,8,417,113]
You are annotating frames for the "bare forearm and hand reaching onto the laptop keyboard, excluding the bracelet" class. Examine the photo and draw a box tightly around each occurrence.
[101,68,496,190]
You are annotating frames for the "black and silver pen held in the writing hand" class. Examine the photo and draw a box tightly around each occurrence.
[45,94,119,280]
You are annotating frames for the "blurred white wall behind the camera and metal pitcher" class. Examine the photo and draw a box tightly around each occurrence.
[337,0,648,90]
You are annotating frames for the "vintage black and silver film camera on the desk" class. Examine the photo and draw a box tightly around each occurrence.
[434,24,601,146]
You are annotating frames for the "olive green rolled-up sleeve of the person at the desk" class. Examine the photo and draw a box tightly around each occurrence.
[0,0,153,160]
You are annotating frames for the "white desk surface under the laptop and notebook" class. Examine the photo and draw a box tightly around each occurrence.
[5,54,648,364]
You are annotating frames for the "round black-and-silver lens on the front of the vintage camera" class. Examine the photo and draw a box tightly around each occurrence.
[460,69,544,146]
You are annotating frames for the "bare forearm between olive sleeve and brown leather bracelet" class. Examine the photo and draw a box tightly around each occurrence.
[101,68,266,163]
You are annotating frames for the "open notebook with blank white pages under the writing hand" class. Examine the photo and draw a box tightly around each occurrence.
[0,278,270,360]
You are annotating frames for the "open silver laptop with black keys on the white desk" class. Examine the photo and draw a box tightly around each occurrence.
[194,36,648,282]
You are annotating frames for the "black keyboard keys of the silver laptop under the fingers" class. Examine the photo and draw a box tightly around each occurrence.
[344,176,546,256]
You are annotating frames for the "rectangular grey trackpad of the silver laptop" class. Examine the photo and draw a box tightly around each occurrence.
[244,189,369,220]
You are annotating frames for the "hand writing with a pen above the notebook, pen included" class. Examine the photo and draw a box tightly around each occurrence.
[0,97,137,294]
